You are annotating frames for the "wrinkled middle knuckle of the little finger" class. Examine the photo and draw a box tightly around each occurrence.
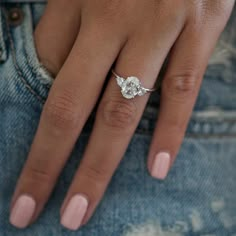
[162,74,199,100]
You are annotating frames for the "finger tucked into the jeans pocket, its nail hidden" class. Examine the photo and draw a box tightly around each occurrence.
[34,0,81,76]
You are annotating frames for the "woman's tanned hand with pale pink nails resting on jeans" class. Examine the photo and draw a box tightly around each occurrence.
[10,0,234,230]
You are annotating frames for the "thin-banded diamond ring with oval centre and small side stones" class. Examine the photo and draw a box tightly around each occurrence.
[111,70,157,99]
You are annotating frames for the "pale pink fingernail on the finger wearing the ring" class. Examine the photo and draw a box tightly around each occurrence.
[61,194,88,230]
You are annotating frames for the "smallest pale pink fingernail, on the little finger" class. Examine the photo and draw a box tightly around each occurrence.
[151,152,170,179]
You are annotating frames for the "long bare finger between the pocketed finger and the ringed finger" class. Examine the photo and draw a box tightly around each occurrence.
[10,24,121,228]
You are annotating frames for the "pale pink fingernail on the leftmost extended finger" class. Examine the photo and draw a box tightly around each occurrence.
[10,195,36,228]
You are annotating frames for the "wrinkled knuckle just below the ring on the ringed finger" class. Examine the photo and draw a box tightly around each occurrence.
[100,99,137,130]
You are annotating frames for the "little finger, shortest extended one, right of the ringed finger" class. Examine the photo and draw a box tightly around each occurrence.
[148,19,230,179]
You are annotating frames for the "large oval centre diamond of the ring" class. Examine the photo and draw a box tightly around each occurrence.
[121,76,141,99]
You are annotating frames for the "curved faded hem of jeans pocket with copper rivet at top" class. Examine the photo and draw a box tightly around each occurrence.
[2,3,53,103]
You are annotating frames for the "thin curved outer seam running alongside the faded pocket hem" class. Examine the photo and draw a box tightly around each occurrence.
[5,8,45,104]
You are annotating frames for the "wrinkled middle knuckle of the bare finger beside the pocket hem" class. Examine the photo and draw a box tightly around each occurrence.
[44,90,80,131]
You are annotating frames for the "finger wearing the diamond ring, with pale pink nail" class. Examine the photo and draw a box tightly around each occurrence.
[61,18,184,230]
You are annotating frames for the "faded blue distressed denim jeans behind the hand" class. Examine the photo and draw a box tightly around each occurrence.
[0,1,236,236]
